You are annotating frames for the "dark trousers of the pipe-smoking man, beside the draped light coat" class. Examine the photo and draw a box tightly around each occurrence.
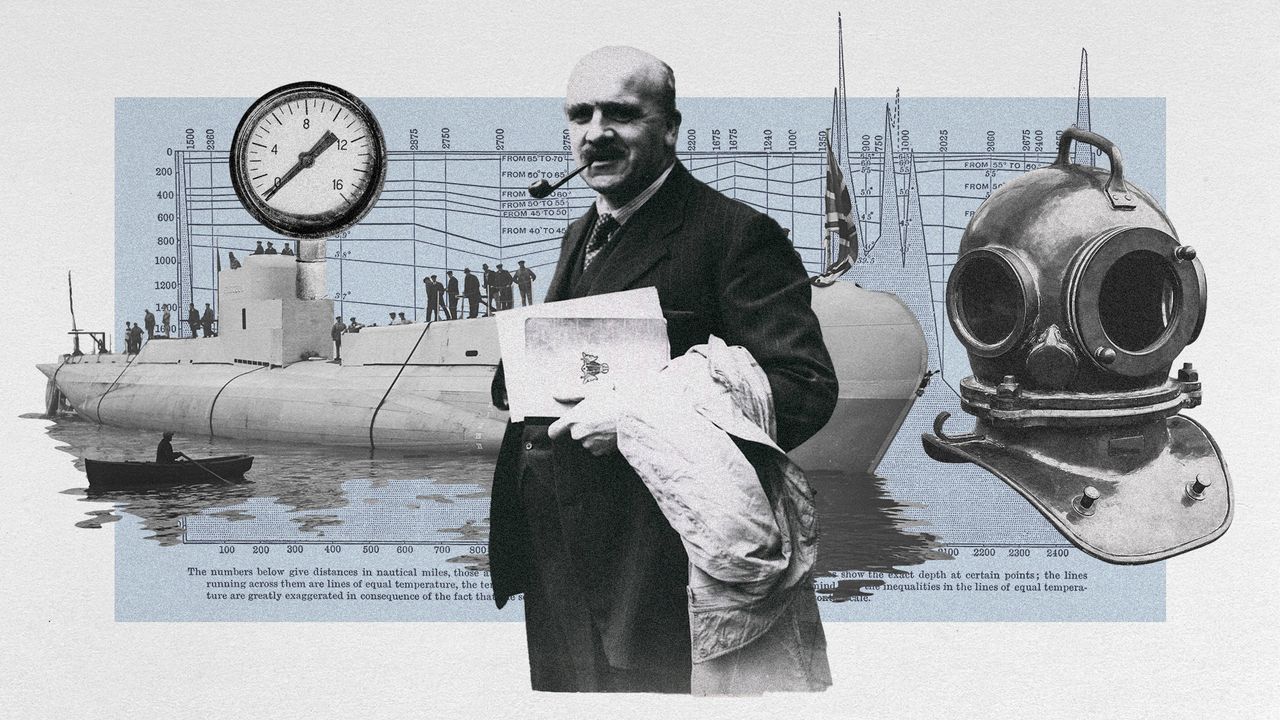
[518,424,692,693]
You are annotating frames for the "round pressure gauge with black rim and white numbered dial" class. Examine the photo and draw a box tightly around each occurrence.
[230,82,387,238]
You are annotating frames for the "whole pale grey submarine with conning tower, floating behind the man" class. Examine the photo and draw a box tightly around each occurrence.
[37,241,928,473]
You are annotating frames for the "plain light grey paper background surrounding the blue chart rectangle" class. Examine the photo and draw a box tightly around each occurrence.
[0,1,1280,719]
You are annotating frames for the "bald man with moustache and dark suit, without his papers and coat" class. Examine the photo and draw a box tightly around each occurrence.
[489,47,837,693]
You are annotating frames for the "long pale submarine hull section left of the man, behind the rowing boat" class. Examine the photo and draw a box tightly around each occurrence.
[41,341,507,454]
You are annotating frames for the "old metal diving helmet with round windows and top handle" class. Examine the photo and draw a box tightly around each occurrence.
[923,127,1231,564]
